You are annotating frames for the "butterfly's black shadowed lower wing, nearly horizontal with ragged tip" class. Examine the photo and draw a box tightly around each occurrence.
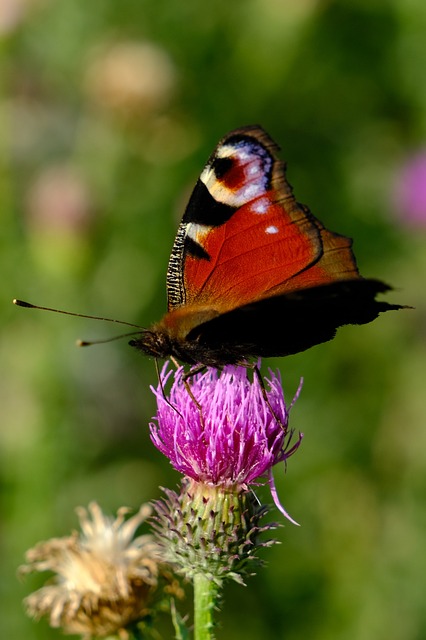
[187,278,403,364]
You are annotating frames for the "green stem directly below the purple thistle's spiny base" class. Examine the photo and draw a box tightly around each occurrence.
[194,573,219,640]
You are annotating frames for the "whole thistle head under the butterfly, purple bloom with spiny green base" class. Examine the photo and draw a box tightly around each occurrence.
[150,363,302,584]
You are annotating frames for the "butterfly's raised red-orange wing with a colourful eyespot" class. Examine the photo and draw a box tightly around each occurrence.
[167,126,360,313]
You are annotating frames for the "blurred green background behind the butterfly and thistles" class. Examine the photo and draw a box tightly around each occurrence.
[0,0,426,640]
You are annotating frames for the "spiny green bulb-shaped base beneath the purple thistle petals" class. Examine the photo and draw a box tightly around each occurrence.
[153,480,279,584]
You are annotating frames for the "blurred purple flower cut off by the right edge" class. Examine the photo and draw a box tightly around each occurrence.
[394,149,426,227]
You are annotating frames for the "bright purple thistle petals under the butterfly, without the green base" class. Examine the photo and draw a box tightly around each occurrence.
[150,362,302,524]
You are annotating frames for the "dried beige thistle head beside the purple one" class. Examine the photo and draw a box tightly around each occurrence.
[20,503,166,638]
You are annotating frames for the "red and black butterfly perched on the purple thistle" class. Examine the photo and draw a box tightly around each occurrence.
[130,125,402,367]
